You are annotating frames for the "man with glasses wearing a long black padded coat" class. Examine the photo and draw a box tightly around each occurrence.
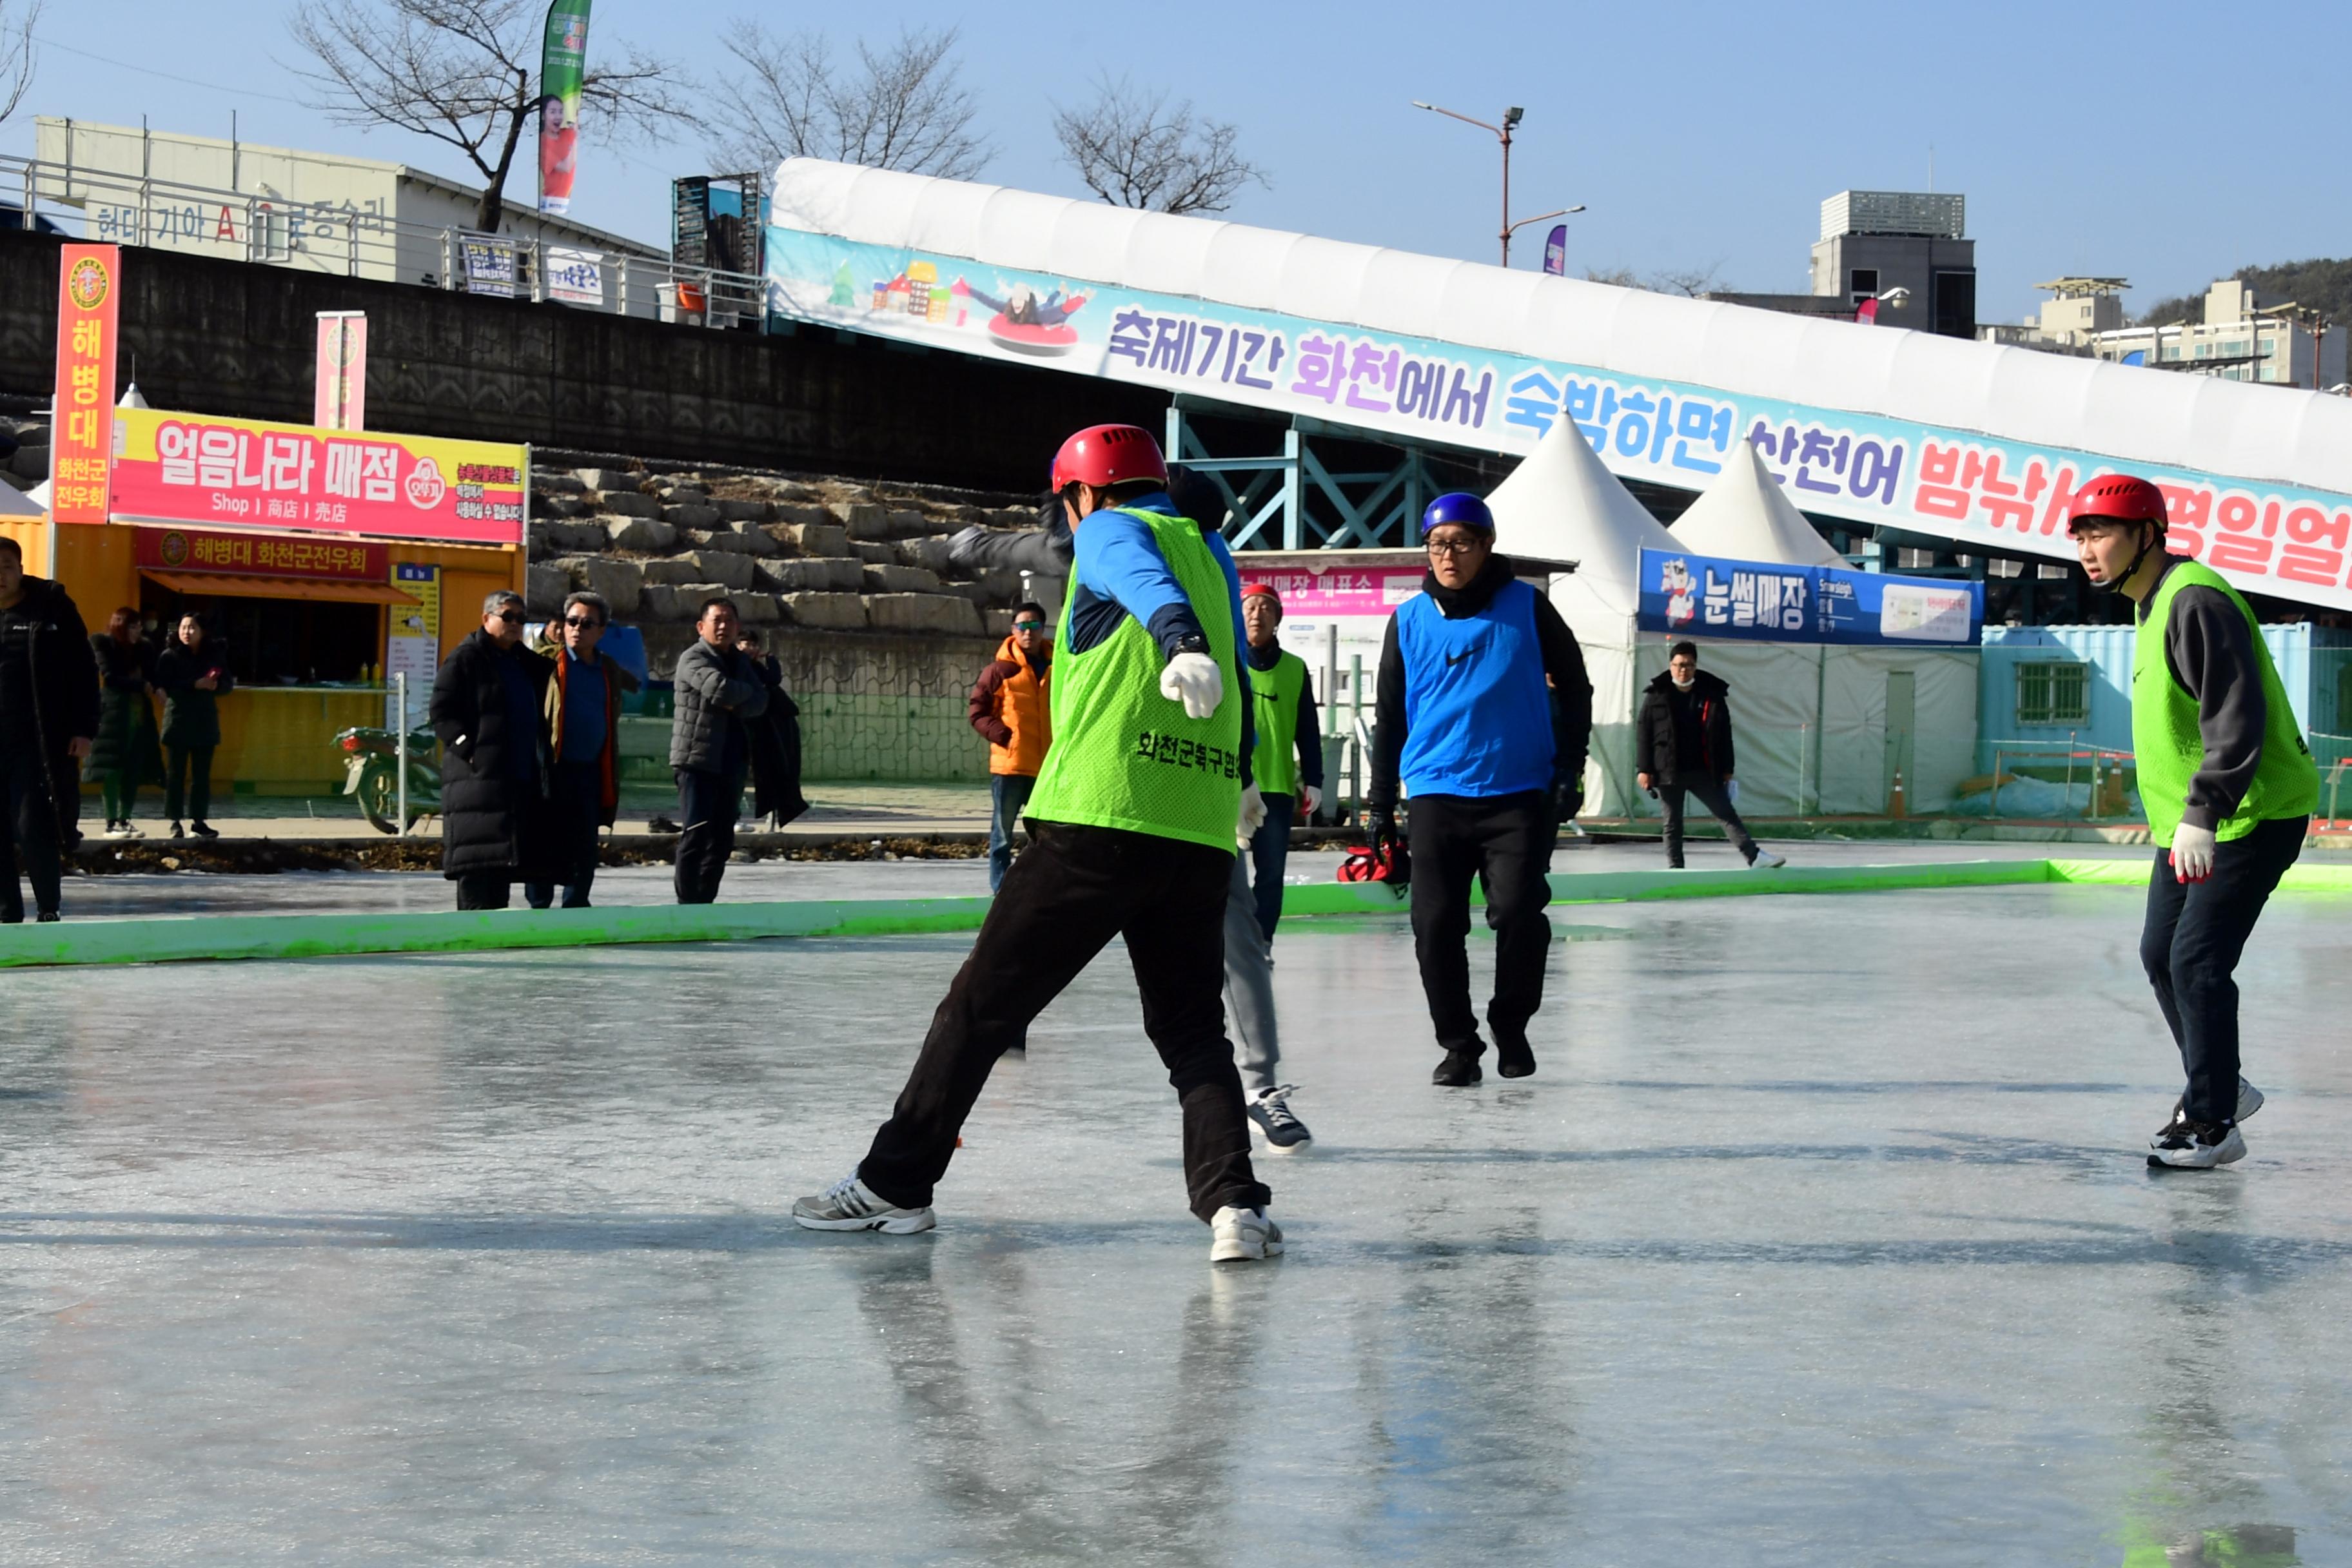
[431,590,555,910]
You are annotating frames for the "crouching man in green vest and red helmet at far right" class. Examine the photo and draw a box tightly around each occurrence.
[2068,475,2319,1171]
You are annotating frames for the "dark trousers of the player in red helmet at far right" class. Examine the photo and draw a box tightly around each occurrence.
[2141,816,2309,1124]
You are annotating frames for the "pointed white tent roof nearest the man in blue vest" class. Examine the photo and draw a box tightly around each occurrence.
[1487,418,1691,616]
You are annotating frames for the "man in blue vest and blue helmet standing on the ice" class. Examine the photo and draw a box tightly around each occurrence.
[1364,491,1592,1088]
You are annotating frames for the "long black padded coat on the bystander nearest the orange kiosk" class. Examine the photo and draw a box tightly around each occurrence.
[431,630,562,881]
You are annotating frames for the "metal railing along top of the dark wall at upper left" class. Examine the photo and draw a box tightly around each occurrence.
[0,157,767,331]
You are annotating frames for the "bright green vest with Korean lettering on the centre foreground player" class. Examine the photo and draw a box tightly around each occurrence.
[1028,508,1242,854]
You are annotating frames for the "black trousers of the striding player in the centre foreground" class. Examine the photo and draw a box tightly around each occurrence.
[859,818,1270,1220]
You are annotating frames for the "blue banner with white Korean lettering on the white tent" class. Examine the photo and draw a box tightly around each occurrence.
[1634,550,1985,649]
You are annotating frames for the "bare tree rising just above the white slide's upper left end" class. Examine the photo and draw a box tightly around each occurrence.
[715,21,995,179]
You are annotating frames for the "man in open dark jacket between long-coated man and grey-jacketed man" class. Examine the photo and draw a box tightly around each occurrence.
[522,593,638,910]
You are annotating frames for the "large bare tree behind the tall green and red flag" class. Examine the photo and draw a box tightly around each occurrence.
[287,0,694,233]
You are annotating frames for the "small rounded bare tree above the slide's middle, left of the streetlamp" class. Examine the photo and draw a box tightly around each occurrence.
[1054,77,1273,211]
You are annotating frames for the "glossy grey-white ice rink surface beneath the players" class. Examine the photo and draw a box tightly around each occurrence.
[0,847,2352,1565]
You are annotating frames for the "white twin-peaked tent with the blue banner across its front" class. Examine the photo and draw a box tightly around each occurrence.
[1487,421,1978,816]
